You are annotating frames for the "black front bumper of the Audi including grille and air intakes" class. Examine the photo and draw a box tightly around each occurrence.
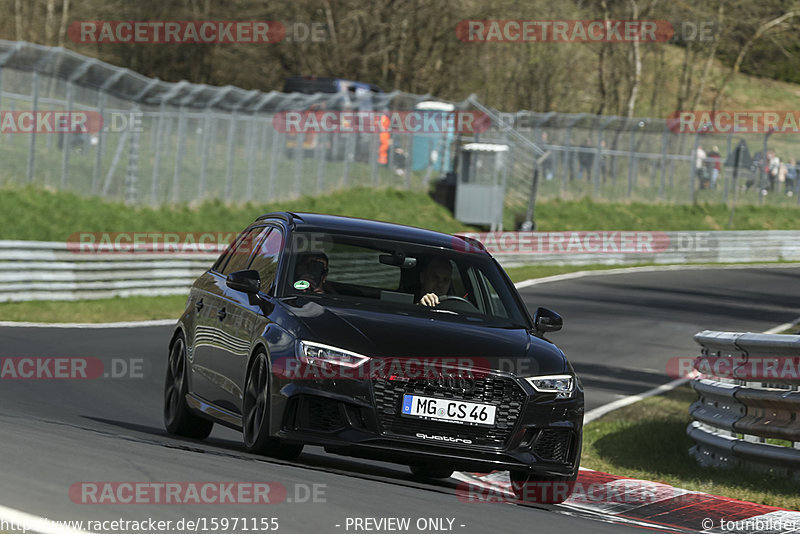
[275,373,584,476]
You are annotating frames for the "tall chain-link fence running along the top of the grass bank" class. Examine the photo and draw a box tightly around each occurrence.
[0,41,800,218]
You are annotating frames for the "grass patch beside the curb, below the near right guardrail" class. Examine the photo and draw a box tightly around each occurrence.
[581,386,800,510]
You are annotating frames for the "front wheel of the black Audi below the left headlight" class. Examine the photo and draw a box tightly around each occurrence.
[242,352,303,460]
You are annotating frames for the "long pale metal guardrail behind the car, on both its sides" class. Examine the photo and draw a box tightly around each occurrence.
[0,230,800,302]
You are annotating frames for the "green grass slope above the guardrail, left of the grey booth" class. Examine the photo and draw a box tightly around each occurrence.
[0,187,471,241]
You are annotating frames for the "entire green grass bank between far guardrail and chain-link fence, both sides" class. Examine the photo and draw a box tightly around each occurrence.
[0,187,800,241]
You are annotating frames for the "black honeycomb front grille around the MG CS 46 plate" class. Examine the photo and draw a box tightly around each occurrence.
[373,375,527,448]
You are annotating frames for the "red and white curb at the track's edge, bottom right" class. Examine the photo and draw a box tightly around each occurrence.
[453,469,800,534]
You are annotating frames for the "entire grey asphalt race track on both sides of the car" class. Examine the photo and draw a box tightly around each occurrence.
[0,267,800,534]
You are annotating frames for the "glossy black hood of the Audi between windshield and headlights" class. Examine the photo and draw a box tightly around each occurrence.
[284,297,569,376]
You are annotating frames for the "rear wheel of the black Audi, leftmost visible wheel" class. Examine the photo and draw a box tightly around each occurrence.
[164,334,214,439]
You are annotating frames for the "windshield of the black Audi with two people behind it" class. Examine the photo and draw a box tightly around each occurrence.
[279,232,527,325]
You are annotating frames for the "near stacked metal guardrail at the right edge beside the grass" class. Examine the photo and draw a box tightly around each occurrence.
[686,330,800,481]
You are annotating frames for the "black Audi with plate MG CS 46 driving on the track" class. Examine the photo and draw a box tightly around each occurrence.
[164,213,584,502]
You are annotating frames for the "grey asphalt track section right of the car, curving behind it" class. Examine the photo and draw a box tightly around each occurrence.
[521,266,800,410]
